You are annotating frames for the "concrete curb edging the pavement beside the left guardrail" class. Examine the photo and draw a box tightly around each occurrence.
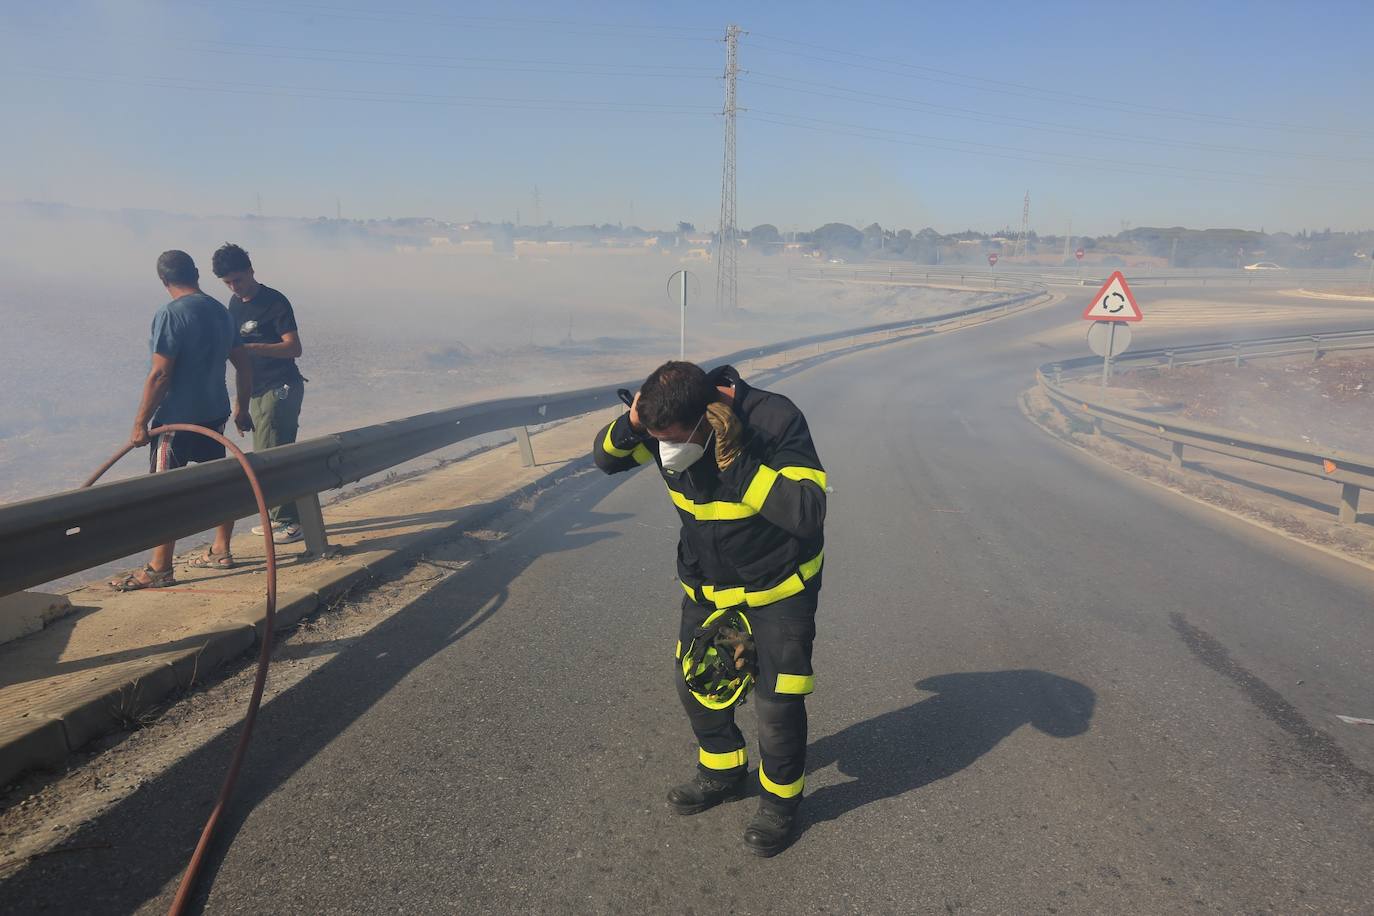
[0,456,592,787]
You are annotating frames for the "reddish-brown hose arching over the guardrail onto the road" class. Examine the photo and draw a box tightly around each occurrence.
[81,423,276,916]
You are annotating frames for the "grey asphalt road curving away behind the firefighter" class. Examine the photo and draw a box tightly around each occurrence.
[0,290,1374,913]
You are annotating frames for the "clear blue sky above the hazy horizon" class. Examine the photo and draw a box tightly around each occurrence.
[0,0,1374,233]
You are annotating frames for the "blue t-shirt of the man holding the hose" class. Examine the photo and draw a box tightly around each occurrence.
[148,293,240,426]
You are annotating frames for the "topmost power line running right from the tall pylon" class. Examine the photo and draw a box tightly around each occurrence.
[753,33,1374,139]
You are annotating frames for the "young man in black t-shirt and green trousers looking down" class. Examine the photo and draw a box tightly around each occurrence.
[212,243,305,544]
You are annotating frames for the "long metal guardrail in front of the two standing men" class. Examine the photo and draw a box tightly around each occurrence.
[0,286,1048,595]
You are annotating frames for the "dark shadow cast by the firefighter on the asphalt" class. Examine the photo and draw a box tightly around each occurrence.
[802,670,1096,824]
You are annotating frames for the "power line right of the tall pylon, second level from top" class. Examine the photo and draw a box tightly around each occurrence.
[745,70,1374,165]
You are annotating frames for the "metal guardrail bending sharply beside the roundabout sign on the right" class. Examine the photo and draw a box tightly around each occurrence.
[1036,328,1374,525]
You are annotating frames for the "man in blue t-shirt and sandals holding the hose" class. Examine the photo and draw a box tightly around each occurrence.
[110,251,253,592]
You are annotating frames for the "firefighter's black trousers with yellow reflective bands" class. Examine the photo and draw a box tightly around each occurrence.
[673,588,818,810]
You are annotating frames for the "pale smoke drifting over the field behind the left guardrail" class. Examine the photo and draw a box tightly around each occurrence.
[0,205,989,501]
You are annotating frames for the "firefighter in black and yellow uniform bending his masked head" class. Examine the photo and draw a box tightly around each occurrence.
[592,361,826,856]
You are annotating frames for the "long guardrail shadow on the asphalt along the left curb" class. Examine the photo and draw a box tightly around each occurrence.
[0,477,624,913]
